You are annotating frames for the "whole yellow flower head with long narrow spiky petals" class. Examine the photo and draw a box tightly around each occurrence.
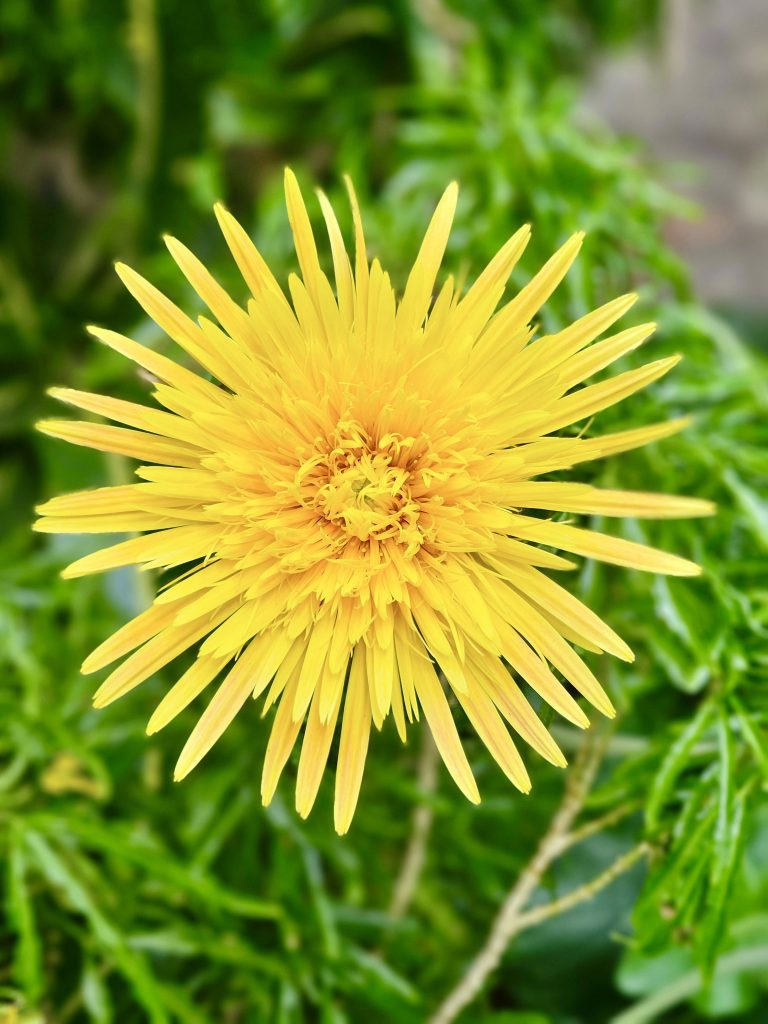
[36,171,712,833]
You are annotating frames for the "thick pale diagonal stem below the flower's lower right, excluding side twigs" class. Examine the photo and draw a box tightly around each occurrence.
[428,731,608,1024]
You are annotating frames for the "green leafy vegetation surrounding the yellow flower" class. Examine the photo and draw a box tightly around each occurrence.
[0,0,768,1024]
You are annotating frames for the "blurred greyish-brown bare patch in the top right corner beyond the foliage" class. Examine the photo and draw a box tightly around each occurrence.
[587,0,768,319]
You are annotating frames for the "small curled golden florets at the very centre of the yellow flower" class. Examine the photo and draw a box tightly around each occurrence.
[304,421,422,554]
